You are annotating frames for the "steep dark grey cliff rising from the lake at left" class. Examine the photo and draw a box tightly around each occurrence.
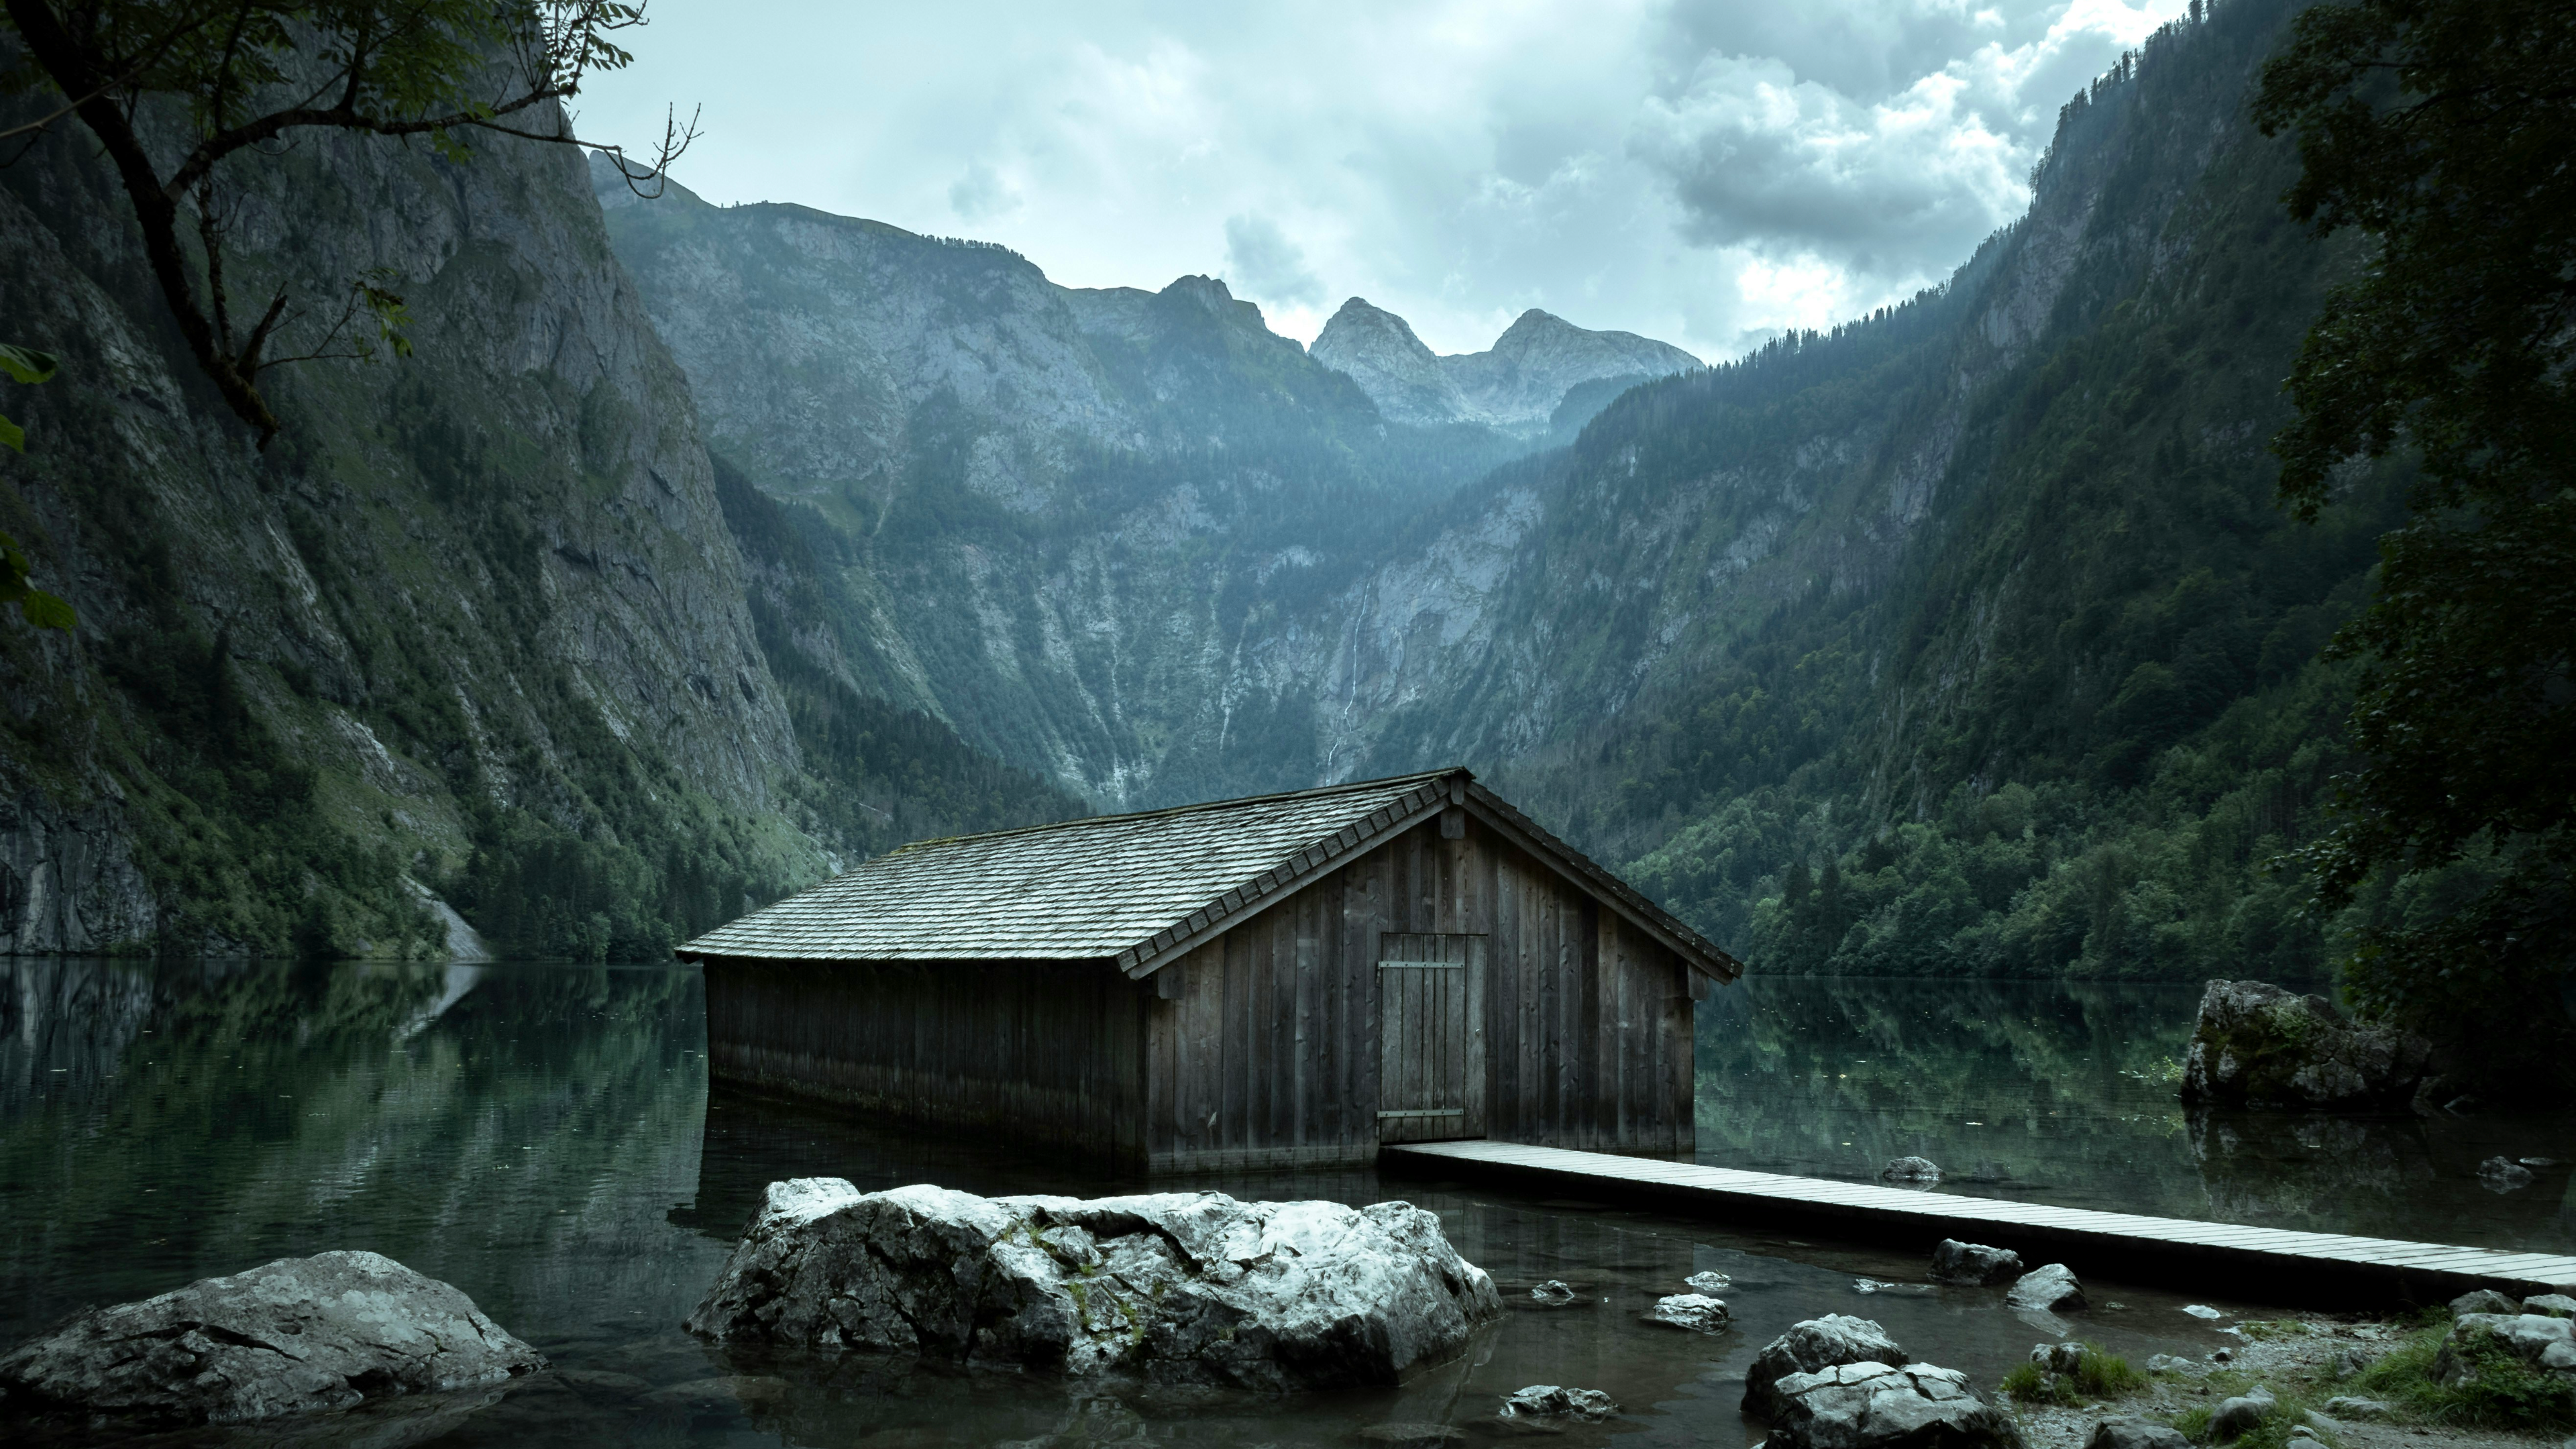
[0,101,1066,957]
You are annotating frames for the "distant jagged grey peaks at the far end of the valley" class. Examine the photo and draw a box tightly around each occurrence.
[1313,297,1700,428]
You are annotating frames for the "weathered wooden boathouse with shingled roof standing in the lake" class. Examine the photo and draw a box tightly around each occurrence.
[680,768,1741,1171]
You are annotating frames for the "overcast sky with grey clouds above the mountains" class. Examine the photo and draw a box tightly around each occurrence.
[580,0,2184,358]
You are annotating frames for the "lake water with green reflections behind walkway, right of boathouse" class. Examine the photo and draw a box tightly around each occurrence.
[1698,977,2576,1253]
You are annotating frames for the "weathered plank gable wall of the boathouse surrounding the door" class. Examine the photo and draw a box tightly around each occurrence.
[1144,820,1693,1171]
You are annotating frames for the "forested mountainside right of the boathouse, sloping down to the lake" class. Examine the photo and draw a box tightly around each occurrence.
[1505,0,2404,977]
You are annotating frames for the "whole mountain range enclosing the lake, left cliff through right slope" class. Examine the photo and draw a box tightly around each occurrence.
[0,0,2414,975]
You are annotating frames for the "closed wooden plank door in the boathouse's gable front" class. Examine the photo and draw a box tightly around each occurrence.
[1378,933,1484,1142]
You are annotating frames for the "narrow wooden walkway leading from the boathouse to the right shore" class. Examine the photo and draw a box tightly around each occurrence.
[1378,1142,2576,1307]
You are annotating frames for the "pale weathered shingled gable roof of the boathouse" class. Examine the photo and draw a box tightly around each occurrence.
[678,768,1741,979]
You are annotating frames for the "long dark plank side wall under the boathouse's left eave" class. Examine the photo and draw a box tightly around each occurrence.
[706,962,1151,1165]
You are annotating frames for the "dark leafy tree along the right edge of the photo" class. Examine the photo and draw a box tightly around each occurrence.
[2254,0,2576,1072]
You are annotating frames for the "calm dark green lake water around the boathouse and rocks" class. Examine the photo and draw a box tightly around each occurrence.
[0,962,2576,1446]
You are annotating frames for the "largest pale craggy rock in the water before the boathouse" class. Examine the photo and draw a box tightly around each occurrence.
[688,1178,1502,1390]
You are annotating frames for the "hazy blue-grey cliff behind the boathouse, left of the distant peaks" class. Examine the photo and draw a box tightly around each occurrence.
[595,175,1520,804]
